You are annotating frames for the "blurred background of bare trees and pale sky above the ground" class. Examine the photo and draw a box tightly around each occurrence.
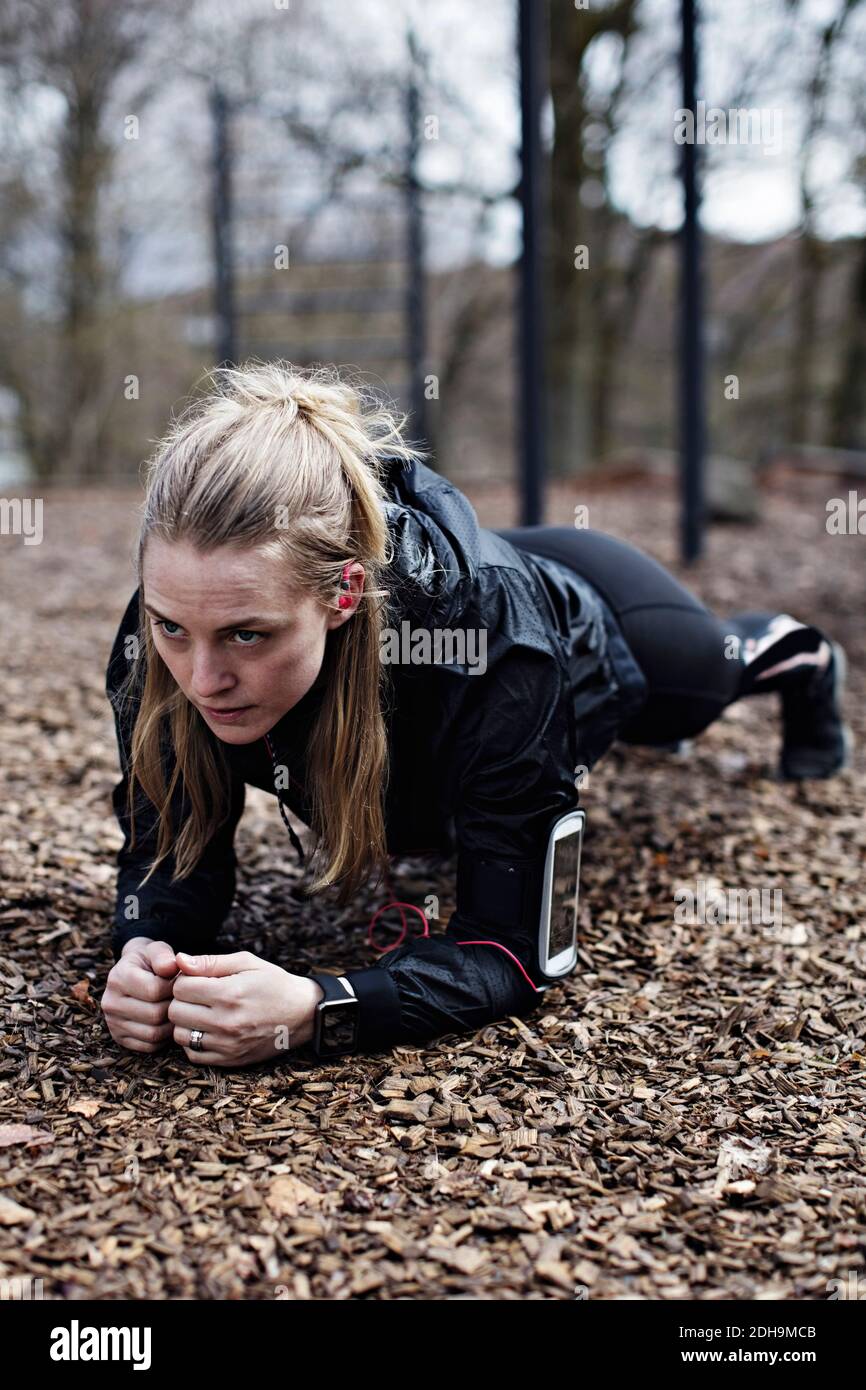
[0,0,866,521]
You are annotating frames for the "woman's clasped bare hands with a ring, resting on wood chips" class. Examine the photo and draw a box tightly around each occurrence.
[101,937,321,1066]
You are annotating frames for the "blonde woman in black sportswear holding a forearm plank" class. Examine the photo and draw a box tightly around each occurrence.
[103,363,849,1066]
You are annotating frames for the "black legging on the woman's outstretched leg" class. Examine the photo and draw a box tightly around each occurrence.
[496,525,822,745]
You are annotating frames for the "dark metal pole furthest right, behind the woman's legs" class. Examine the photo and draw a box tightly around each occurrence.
[680,0,705,564]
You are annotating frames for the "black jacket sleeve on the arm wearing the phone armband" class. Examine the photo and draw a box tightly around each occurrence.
[343,648,578,1052]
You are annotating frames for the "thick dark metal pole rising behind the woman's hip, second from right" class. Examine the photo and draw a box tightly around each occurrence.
[517,0,546,525]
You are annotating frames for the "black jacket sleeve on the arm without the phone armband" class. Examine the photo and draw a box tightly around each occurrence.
[106,589,246,960]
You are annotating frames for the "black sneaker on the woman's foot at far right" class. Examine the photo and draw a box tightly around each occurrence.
[778,642,853,781]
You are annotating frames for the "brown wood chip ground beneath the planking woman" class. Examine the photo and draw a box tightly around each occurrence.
[0,480,866,1300]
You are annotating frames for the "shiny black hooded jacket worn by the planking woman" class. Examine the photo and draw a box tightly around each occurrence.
[106,461,646,1051]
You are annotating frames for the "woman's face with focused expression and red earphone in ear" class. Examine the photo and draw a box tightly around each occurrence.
[143,537,364,744]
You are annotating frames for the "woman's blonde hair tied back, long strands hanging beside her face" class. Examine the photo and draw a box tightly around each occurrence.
[113,359,425,904]
